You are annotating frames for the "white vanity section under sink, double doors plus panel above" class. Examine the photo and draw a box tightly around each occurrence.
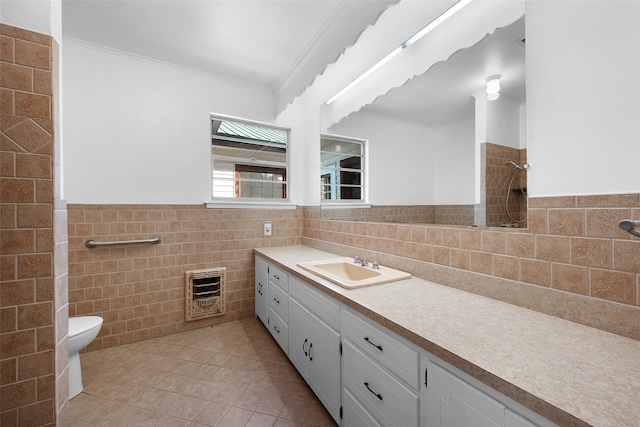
[289,278,341,423]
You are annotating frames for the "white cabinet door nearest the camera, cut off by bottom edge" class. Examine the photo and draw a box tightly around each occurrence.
[426,363,505,427]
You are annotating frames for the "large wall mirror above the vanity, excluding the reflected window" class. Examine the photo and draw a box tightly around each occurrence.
[322,16,527,227]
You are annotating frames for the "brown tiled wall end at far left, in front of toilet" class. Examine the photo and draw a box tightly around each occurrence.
[0,24,68,426]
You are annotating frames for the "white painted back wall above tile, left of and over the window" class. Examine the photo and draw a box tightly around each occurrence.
[64,39,274,204]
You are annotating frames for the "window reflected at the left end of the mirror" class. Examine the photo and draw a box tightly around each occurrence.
[320,135,364,202]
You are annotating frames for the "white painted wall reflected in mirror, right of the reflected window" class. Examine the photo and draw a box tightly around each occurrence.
[328,112,438,205]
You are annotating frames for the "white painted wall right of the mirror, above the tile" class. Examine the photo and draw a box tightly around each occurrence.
[526,0,640,196]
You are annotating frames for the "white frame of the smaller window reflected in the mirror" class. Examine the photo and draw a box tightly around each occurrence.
[319,133,371,209]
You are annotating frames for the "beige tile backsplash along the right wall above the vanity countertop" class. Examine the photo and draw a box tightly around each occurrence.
[303,194,640,339]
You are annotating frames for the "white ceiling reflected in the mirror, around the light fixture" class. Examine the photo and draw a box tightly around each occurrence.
[361,17,526,127]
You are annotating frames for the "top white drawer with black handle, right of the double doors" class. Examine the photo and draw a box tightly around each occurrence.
[341,310,420,389]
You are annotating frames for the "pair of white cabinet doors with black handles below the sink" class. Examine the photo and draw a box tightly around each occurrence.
[289,299,340,422]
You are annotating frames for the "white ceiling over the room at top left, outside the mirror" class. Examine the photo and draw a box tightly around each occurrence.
[62,0,398,108]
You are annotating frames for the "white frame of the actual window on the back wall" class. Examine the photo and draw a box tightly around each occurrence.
[205,113,297,209]
